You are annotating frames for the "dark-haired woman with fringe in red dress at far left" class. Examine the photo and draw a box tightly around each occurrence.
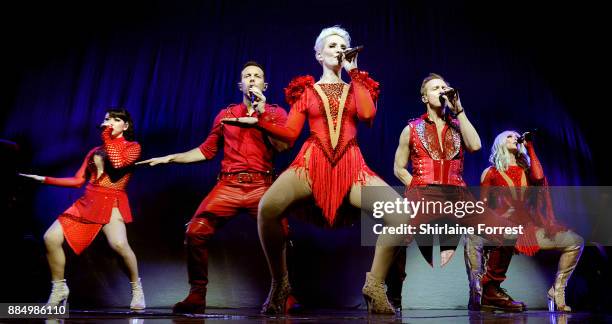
[21,109,145,310]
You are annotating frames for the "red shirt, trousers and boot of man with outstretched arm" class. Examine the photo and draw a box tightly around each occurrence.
[180,103,287,308]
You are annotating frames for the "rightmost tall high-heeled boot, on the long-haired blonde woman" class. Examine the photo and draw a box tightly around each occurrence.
[548,242,584,312]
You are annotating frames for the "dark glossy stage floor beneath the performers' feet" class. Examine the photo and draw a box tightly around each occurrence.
[0,308,612,324]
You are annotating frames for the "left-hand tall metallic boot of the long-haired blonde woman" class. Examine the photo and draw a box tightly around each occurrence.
[463,235,485,311]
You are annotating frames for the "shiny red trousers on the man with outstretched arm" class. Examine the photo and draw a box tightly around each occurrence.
[185,177,288,295]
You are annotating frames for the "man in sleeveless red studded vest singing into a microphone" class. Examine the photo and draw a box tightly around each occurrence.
[388,73,524,312]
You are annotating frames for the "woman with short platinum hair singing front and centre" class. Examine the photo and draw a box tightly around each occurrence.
[230,26,408,314]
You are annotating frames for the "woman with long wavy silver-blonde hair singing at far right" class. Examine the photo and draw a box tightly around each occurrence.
[474,131,584,312]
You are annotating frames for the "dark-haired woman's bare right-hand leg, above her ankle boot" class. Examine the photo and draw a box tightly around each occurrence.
[102,208,138,282]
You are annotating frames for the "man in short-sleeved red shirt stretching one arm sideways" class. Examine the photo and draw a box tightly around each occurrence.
[137,61,294,313]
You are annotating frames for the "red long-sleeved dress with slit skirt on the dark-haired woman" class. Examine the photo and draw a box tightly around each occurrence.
[44,128,141,254]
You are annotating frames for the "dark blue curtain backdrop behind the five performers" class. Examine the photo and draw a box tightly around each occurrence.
[0,0,608,308]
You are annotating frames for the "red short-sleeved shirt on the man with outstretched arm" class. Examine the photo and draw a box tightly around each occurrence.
[200,103,287,172]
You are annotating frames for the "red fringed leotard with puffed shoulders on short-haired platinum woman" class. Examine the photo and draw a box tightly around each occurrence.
[259,69,379,225]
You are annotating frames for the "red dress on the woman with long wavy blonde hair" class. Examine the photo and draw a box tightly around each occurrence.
[481,145,567,256]
